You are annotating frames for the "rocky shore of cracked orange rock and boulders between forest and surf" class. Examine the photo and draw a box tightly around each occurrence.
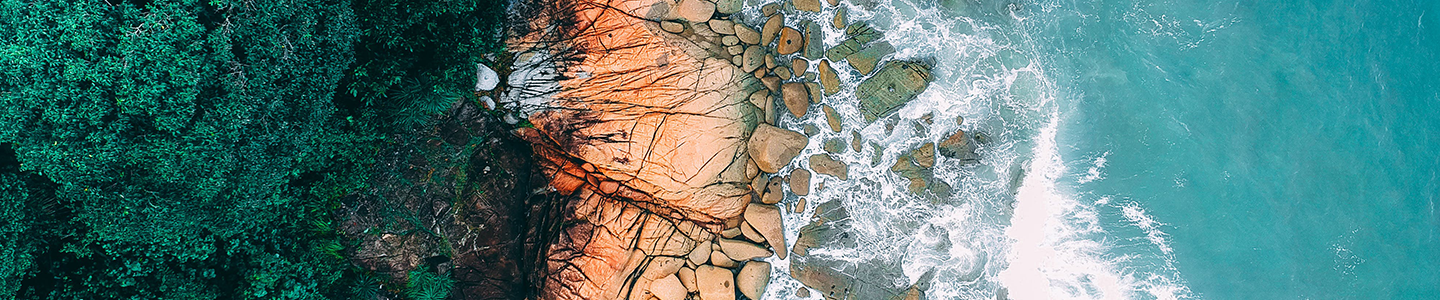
[500,0,973,300]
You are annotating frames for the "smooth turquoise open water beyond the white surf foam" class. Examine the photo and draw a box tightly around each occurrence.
[1015,0,1440,299]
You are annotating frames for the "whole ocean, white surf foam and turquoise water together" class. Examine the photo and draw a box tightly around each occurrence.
[744,0,1440,299]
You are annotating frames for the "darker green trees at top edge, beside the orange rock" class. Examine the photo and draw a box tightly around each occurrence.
[337,0,507,130]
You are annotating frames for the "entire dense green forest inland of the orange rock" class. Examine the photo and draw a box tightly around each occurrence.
[0,0,508,299]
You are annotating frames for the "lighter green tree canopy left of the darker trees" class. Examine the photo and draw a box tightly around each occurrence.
[0,0,359,299]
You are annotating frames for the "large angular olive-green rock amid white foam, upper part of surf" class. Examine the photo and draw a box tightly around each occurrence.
[855,62,932,121]
